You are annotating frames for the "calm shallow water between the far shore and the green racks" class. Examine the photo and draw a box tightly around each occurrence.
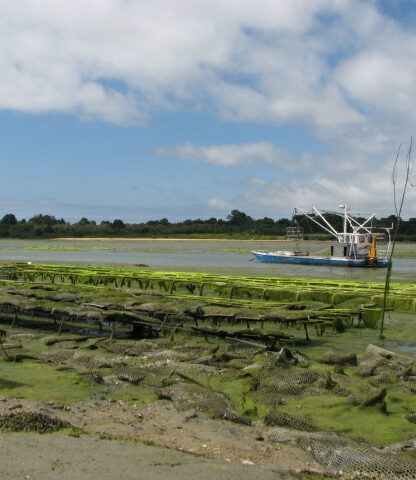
[0,239,416,283]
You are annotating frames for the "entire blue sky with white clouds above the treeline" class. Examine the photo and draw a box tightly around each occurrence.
[0,0,416,223]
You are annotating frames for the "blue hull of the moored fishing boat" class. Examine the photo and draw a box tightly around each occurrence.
[251,252,389,267]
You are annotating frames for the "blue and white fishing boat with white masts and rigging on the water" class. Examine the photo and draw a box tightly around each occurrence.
[251,205,392,267]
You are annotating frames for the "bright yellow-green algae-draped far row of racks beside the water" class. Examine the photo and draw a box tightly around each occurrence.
[1,264,416,312]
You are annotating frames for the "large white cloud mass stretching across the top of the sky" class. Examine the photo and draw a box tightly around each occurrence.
[0,0,416,130]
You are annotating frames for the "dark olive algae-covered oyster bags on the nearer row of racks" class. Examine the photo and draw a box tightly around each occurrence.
[0,272,386,346]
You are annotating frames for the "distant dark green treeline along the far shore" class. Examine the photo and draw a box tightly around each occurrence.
[0,210,416,241]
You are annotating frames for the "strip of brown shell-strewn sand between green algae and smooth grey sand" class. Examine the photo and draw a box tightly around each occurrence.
[0,396,320,474]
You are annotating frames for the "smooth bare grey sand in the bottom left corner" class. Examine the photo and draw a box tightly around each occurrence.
[0,433,295,480]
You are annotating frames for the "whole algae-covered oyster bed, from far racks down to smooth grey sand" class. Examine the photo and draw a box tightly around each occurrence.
[0,264,416,479]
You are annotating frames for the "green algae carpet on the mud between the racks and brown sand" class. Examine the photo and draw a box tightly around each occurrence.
[0,319,416,450]
